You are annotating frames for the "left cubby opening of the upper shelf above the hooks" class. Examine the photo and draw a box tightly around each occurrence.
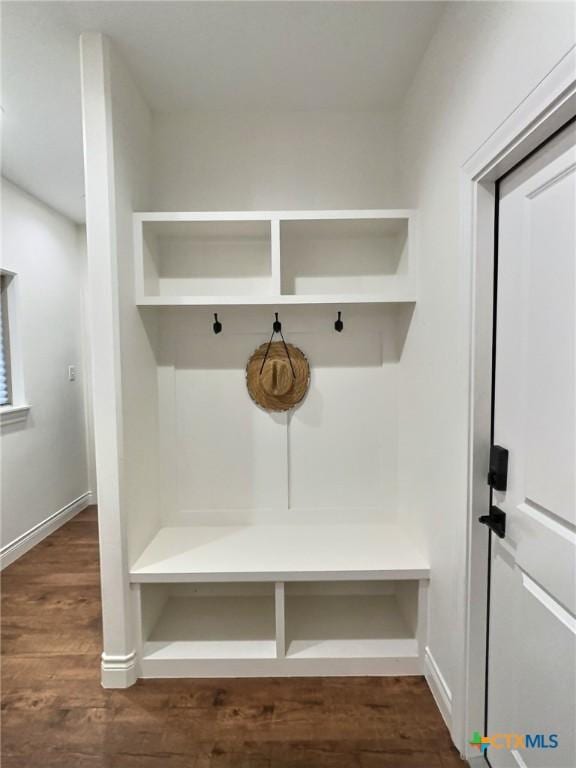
[141,220,272,297]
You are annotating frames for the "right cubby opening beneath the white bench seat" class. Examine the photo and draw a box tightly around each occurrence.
[285,581,419,659]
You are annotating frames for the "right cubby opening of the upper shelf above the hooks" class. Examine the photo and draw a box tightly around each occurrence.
[280,218,409,296]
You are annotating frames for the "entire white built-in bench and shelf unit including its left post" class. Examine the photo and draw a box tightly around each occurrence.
[82,34,430,687]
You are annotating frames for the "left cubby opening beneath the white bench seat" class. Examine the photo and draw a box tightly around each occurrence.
[141,583,276,660]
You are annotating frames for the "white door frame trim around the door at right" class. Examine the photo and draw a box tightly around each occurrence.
[452,46,576,766]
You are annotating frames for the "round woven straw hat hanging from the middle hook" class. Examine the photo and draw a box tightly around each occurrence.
[246,341,310,411]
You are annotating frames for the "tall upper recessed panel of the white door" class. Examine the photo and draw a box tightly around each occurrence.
[522,161,576,524]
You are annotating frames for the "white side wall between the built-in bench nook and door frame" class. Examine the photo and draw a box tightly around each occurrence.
[399,3,574,746]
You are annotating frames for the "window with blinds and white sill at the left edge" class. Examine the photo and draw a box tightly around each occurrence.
[0,270,30,425]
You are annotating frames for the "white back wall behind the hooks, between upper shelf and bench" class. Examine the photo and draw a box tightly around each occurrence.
[154,306,400,525]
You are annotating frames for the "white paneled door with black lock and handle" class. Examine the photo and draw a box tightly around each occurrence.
[486,125,576,768]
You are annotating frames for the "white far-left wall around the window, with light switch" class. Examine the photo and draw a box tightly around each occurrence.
[1,180,94,549]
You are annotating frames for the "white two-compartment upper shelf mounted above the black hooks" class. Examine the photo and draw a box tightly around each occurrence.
[134,210,417,307]
